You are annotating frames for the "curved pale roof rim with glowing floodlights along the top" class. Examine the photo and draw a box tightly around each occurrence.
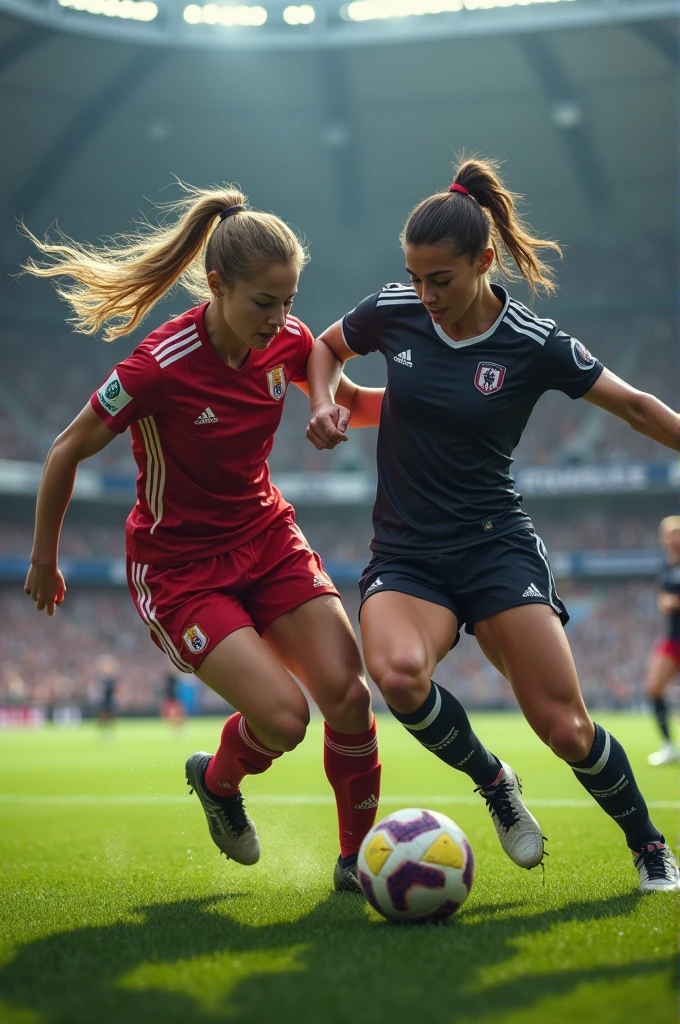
[0,0,679,48]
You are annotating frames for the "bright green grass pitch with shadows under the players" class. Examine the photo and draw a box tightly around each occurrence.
[0,715,678,1024]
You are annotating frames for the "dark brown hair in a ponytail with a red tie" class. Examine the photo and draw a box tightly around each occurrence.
[400,157,562,295]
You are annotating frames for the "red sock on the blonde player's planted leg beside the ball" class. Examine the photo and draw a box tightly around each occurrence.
[324,718,380,857]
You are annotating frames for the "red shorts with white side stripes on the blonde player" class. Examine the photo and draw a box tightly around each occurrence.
[127,514,340,672]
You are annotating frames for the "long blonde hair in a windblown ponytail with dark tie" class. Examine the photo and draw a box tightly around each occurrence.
[22,182,307,341]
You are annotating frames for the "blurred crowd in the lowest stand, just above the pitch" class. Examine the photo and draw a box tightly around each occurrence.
[0,583,662,714]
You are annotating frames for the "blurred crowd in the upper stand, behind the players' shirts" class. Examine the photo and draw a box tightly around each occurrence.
[0,312,678,475]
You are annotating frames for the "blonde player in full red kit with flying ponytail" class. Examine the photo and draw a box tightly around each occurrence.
[25,186,383,892]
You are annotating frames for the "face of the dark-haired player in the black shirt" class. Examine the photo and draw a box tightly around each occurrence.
[405,245,494,327]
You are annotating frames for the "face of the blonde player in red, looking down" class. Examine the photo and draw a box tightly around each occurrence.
[220,263,300,349]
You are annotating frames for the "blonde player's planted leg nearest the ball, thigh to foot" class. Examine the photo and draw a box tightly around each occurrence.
[263,594,380,892]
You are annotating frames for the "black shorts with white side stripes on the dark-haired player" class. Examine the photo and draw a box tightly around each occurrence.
[358,529,569,646]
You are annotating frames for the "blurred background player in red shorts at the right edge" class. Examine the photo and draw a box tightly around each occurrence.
[645,515,680,765]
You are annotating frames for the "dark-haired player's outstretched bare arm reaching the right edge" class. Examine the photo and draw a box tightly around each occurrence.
[583,370,680,452]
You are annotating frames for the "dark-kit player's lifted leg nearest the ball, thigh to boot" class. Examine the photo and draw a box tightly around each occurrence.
[362,591,543,868]
